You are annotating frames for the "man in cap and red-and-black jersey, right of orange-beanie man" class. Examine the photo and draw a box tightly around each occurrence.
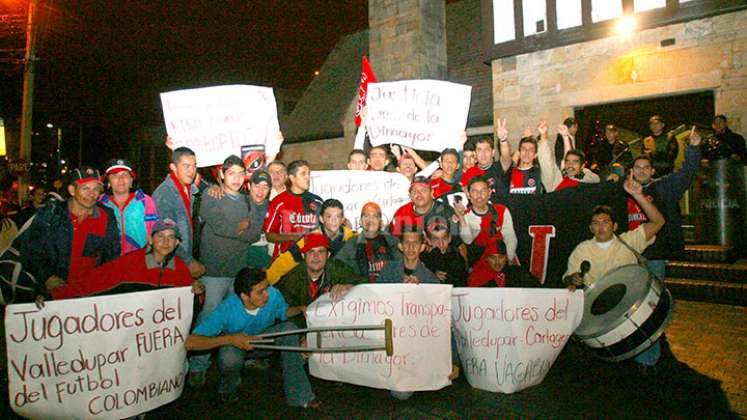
[389,176,456,237]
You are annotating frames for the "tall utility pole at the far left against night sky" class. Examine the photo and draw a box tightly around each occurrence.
[18,0,39,205]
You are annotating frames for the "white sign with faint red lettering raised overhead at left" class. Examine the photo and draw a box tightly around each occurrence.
[161,85,280,167]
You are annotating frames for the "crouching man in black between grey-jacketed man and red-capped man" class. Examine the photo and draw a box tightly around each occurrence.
[420,220,467,287]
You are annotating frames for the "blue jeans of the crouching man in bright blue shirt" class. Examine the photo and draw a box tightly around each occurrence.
[218,321,316,407]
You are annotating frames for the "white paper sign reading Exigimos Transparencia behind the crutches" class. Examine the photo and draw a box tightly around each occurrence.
[306,284,451,391]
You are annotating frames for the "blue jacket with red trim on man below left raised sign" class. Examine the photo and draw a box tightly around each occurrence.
[153,175,199,265]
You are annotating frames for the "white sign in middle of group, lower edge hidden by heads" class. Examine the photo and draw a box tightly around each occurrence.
[309,170,410,229]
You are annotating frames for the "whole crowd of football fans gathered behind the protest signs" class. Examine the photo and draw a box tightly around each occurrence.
[4,110,744,408]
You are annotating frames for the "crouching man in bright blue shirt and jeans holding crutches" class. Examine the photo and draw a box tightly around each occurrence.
[184,268,320,408]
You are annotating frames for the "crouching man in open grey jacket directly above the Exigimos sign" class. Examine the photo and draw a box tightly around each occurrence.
[376,225,439,284]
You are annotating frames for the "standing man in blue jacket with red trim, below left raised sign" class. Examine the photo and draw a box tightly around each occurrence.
[153,147,205,278]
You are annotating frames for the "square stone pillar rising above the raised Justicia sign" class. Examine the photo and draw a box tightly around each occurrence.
[368,0,446,82]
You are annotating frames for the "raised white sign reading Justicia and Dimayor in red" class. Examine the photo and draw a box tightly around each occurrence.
[366,80,472,152]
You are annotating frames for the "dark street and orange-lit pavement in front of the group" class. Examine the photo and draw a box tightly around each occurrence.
[0,301,747,419]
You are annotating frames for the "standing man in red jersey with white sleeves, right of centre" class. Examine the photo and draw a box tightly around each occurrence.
[454,176,518,267]
